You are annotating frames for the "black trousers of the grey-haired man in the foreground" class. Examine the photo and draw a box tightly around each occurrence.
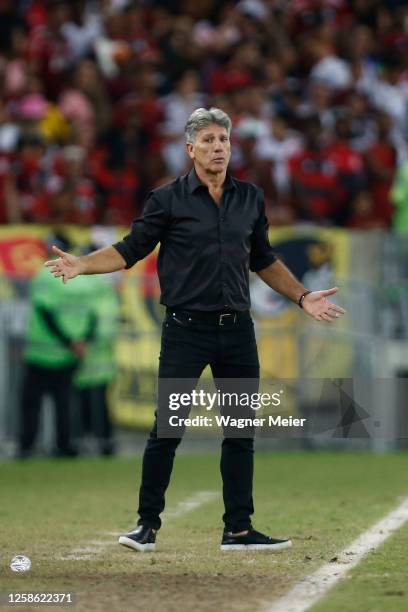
[138,312,259,531]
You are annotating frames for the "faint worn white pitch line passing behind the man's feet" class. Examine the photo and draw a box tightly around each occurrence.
[57,491,219,561]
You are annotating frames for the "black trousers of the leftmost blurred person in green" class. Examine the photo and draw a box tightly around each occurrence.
[20,363,74,454]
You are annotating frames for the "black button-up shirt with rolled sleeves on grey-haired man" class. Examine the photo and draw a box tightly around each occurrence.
[113,169,276,311]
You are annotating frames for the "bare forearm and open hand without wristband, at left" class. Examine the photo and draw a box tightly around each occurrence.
[44,246,126,283]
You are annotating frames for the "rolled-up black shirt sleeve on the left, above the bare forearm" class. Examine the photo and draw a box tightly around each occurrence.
[112,194,168,269]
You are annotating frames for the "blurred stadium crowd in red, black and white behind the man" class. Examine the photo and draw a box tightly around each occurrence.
[0,0,408,228]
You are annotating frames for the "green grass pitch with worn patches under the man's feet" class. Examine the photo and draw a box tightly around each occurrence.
[0,451,408,612]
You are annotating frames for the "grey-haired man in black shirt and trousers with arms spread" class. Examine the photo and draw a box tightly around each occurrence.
[46,108,344,550]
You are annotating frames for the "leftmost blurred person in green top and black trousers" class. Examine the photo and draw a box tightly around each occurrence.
[18,236,95,459]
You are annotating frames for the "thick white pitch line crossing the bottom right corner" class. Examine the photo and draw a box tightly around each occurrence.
[262,498,408,612]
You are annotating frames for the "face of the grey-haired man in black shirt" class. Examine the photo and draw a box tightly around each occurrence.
[187,123,231,174]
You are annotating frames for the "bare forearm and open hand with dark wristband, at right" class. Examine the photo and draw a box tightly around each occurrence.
[257,260,346,321]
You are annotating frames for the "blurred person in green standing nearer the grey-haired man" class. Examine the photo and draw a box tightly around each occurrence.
[74,262,119,456]
